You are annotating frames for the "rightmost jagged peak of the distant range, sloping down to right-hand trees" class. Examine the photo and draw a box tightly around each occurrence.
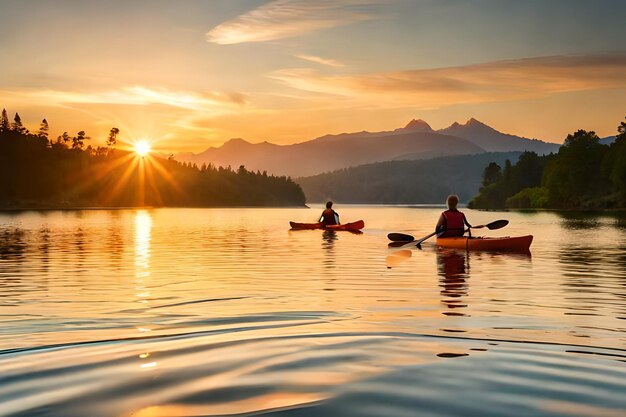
[437,118,560,155]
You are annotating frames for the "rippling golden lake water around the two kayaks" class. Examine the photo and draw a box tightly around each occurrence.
[0,205,626,417]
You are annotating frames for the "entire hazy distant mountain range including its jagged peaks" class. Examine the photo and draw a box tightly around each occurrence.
[174,118,559,177]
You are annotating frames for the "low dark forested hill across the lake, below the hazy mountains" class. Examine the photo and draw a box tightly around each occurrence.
[295,152,521,204]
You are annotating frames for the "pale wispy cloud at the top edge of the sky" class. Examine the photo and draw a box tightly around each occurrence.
[206,0,373,45]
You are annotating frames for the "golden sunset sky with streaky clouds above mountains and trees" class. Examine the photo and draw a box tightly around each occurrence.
[0,0,626,152]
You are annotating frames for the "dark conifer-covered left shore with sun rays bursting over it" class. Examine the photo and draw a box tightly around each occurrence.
[0,110,305,208]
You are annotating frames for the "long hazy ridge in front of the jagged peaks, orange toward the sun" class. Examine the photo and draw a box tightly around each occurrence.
[175,130,485,177]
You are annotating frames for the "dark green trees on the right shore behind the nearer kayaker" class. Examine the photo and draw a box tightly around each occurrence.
[469,116,626,209]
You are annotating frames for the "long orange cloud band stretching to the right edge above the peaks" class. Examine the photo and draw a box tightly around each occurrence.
[270,54,626,109]
